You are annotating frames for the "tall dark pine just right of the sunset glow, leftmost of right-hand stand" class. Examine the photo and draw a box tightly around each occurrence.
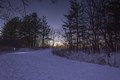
[63,0,85,50]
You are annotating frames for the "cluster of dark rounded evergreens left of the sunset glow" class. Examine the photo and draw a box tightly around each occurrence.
[0,13,51,48]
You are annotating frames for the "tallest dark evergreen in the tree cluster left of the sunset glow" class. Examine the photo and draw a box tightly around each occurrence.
[20,13,41,47]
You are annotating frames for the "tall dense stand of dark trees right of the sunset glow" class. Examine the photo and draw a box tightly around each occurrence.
[62,0,120,53]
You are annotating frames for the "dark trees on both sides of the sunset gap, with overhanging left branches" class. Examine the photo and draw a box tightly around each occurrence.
[0,0,120,53]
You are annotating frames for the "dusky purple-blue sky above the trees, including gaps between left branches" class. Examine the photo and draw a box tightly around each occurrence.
[0,0,81,29]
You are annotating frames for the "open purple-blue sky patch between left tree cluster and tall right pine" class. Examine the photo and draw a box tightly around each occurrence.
[27,0,69,29]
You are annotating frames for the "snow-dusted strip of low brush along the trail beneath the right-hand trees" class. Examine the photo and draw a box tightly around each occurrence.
[53,49,120,67]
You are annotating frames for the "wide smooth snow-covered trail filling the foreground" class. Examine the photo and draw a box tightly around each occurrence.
[0,49,120,80]
